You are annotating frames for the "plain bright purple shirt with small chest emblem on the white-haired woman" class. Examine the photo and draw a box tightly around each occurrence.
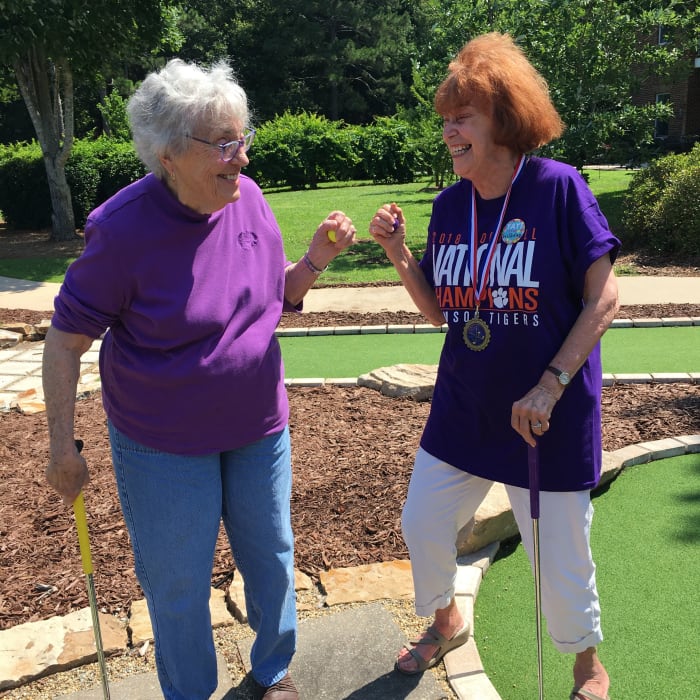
[52,174,288,455]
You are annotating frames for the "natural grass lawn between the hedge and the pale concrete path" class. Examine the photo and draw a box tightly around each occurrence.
[0,170,632,285]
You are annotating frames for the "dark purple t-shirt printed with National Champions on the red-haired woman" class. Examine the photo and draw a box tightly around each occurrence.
[420,157,620,491]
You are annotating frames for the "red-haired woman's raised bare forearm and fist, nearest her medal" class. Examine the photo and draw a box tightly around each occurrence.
[369,204,445,326]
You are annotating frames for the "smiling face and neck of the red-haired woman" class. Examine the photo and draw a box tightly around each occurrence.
[442,104,517,198]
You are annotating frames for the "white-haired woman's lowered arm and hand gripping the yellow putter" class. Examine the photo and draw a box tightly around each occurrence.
[42,326,92,505]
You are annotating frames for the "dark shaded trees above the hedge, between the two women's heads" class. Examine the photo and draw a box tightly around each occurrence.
[180,0,415,124]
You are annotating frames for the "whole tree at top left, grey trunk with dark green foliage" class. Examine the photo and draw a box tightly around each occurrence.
[0,0,162,241]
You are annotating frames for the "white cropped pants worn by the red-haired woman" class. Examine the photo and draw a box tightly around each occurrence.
[401,448,603,654]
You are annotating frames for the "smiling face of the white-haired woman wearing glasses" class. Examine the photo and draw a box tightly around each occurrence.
[161,125,250,214]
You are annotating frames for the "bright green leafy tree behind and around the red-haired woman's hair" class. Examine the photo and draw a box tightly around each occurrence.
[414,0,700,168]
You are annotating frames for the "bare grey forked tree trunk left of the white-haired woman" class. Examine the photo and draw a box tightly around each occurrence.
[14,46,76,241]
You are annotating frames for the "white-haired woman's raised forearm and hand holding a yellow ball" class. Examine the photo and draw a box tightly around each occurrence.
[284,211,355,306]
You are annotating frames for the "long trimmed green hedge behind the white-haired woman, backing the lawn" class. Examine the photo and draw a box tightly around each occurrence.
[0,112,434,229]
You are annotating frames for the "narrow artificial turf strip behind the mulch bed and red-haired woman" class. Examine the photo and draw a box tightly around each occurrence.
[280,326,700,378]
